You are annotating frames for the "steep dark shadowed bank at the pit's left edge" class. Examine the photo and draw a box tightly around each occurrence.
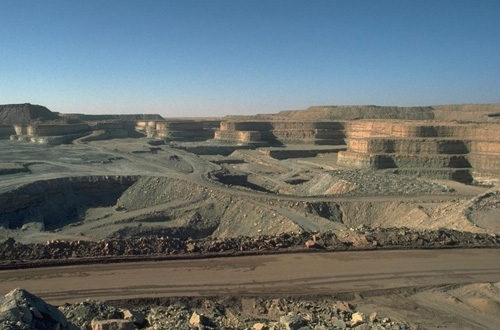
[0,176,137,230]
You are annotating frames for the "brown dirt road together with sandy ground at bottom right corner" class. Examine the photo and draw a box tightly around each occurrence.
[0,249,500,329]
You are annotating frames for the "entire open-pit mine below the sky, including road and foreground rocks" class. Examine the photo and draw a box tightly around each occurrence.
[0,104,500,329]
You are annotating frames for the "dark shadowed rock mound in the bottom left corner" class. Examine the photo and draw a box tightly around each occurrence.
[0,288,68,330]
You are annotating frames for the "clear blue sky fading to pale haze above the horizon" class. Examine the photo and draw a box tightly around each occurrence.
[0,0,500,116]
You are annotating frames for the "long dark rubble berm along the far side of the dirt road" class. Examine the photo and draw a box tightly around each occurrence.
[0,226,500,268]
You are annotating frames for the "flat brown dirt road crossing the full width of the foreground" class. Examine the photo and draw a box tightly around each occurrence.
[0,249,500,304]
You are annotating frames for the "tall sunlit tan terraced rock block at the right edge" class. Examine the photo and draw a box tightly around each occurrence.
[337,121,500,183]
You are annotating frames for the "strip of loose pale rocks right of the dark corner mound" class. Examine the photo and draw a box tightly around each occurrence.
[60,297,412,330]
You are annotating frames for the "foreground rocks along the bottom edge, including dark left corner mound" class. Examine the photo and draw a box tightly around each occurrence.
[0,288,412,330]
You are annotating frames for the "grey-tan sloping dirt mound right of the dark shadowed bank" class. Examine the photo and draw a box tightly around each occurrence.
[112,177,300,237]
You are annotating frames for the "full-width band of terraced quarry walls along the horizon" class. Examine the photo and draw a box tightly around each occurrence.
[0,103,500,182]
